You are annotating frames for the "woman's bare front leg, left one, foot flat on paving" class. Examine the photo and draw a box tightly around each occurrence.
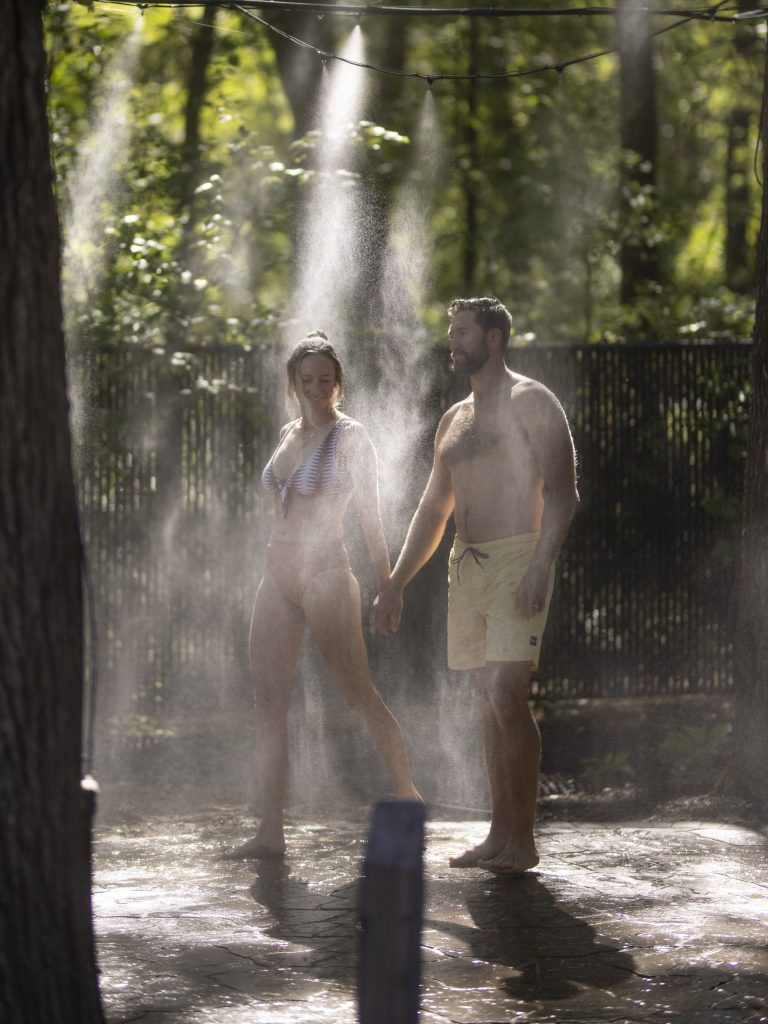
[226,573,304,860]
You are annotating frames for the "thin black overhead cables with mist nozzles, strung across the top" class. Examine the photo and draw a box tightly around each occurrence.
[93,0,768,82]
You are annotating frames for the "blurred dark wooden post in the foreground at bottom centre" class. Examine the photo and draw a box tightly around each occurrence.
[359,801,425,1024]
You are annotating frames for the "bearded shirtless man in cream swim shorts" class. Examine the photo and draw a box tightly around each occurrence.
[375,298,579,873]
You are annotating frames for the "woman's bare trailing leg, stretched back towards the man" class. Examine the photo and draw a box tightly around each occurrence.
[302,568,421,800]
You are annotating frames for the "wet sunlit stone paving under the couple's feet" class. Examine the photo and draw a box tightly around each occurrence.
[94,810,768,1024]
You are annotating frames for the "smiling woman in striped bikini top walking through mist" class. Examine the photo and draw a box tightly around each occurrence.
[227,331,421,859]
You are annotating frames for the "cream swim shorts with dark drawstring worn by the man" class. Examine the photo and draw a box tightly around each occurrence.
[447,534,555,669]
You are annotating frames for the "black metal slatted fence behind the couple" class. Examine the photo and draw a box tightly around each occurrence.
[74,343,750,731]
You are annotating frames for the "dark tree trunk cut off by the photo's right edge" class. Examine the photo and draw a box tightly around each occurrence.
[731,36,768,812]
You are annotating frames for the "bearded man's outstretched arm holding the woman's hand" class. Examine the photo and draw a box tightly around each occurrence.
[374,410,454,636]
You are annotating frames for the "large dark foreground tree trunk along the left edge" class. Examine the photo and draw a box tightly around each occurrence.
[0,0,102,1024]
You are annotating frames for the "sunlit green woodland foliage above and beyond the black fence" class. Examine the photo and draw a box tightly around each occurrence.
[47,3,765,348]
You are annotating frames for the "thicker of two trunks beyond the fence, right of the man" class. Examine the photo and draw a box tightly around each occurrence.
[616,0,659,304]
